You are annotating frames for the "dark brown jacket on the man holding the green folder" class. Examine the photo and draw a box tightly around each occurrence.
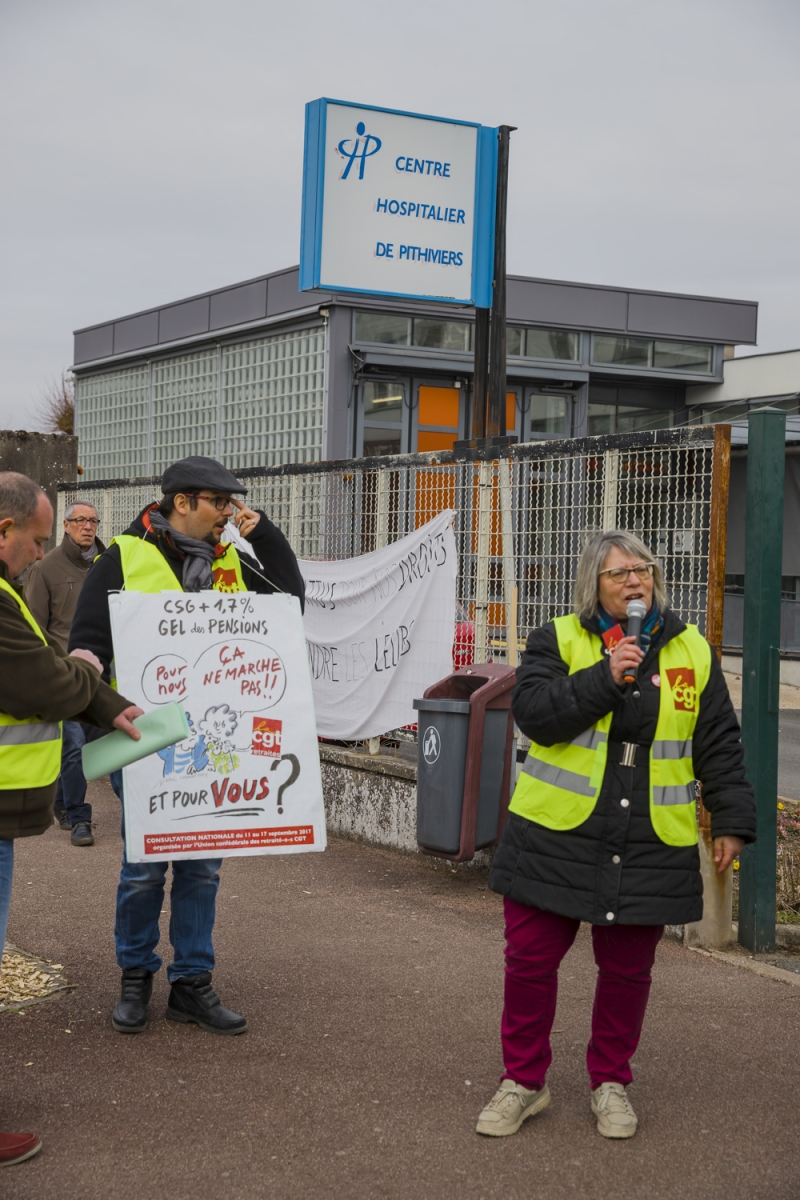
[0,562,131,838]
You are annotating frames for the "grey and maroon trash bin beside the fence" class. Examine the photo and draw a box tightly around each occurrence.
[414,662,516,863]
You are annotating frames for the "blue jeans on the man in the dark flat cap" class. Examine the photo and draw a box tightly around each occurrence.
[110,770,222,983]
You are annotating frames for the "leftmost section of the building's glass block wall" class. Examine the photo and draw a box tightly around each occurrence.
[76,362,150,479]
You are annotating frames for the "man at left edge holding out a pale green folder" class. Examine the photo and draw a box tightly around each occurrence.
[0,470,142,1166]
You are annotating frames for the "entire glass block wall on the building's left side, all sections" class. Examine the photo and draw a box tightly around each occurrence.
[76,325,326,479]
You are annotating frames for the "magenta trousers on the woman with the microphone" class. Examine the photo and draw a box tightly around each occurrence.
[501,896,664,1091]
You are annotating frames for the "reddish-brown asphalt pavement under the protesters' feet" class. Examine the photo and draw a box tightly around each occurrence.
[0,785,800,1200]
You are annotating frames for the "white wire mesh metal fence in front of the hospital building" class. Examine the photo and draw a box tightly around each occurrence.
[59,426,729,662]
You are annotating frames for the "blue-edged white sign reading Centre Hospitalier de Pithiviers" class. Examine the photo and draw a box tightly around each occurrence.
[300,98,498,308]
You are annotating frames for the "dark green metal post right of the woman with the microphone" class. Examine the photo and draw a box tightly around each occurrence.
[739,408,786,954]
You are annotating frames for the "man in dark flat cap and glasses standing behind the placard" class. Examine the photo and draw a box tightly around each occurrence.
[70,455,305,1034]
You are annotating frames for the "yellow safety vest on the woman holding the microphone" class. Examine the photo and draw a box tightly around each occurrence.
[510,613,711,846]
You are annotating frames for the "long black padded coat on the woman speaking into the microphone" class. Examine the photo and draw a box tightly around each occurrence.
[489,611,756,925]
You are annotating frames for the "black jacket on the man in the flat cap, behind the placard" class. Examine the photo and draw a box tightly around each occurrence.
[70,505,306,678]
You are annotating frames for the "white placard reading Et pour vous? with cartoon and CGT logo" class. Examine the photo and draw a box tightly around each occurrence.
[109,592,325,863]
